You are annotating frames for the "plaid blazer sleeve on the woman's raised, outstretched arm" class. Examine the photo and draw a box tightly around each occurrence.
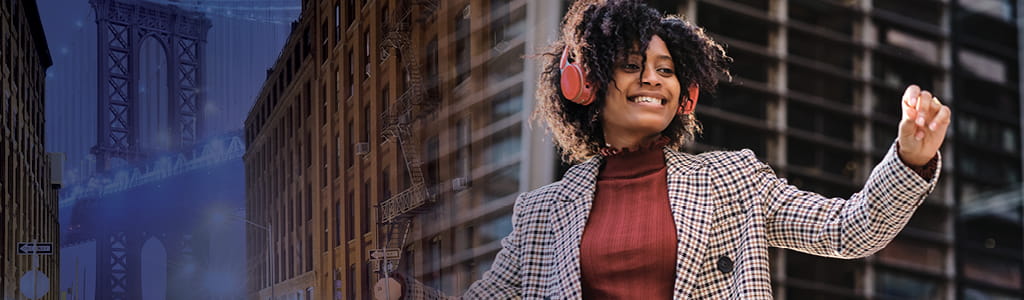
[745,142,942,259]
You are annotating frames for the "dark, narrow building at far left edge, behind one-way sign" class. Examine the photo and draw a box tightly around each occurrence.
[0,0,62,300]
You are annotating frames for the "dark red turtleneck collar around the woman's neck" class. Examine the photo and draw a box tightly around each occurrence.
[597,136,669,179]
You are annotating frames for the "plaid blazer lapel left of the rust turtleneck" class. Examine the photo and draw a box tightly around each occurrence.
[552,156,602,299]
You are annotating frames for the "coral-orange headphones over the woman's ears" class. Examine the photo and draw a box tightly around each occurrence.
[558,46,700,115]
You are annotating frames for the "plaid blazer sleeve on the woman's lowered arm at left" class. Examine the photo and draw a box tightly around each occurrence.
[402,194,526,300]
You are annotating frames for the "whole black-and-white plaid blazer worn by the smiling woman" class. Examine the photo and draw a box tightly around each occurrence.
[404,143,941,299]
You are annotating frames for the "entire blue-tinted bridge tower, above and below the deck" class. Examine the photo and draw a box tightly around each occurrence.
[89,0,211,300]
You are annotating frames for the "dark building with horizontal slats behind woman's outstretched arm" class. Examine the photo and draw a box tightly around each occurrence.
[650,0,1024,299]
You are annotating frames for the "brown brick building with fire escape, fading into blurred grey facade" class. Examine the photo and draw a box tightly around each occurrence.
[245,0,560,299]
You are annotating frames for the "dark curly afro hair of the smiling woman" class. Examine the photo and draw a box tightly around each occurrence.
[534,0,732,163]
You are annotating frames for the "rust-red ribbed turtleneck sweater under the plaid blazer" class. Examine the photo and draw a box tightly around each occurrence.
[580,137,677,299]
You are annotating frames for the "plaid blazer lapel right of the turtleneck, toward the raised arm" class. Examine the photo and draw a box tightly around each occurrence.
[665,147,715,299]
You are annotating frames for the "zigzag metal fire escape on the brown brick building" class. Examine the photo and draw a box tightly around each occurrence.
[370,0,440,276]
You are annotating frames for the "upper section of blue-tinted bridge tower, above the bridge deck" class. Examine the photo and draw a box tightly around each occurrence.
[89,0,211,168]
